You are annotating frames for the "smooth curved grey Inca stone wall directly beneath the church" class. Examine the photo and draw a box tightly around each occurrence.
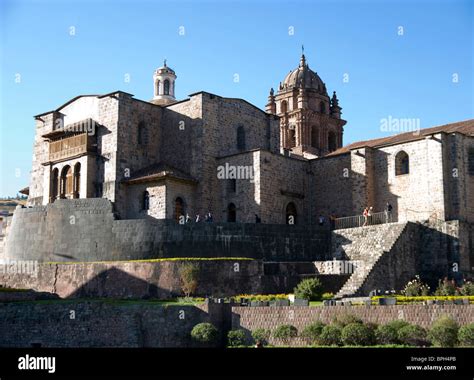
[5,198,329,262]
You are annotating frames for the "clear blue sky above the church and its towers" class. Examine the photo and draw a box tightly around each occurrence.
[0,0,474,196]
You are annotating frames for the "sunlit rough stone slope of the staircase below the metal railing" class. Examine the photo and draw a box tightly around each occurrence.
[331,223,407,298]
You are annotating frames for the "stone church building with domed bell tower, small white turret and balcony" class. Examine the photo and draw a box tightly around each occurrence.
[28,55,474,230]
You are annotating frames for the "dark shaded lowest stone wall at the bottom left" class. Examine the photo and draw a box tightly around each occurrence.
[0,301,222,347]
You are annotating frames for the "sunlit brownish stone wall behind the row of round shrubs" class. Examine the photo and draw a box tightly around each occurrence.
[232,305,474,345]
